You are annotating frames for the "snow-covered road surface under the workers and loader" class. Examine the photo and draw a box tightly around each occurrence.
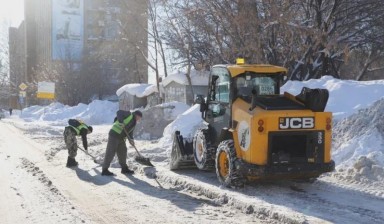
[0,119,384,223]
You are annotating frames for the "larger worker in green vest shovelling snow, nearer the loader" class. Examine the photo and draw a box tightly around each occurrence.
[101,110,143,176]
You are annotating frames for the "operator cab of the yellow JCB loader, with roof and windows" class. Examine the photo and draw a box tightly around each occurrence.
[200,65,286,146]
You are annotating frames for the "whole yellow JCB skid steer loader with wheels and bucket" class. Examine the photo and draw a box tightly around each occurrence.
[171,58,335,186]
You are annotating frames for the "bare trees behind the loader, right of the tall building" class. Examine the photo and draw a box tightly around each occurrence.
[150,0,384,80]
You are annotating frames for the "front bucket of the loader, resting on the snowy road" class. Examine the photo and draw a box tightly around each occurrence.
[169,131,196,170]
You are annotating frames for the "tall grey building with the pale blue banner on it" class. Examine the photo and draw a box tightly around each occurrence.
[10,0,148,103]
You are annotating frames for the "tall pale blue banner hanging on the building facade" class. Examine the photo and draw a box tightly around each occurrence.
[52,0,84,61]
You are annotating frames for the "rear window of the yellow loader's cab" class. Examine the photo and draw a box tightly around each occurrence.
[235,72,282,102]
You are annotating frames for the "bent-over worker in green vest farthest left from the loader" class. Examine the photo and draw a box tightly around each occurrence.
[64,119,93,167]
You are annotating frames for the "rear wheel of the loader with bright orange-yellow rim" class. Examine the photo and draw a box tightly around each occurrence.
[215,140,245,187]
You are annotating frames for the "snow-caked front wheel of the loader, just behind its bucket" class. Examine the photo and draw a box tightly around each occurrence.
[193,129,215,170]
